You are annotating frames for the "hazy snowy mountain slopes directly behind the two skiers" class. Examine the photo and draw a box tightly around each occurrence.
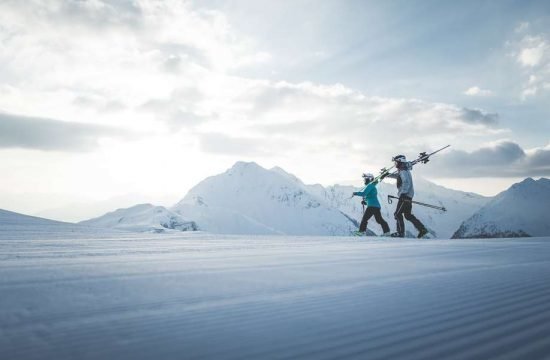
[307,178,489,238]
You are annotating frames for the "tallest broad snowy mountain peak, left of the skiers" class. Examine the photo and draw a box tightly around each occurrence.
[172,162,357,235]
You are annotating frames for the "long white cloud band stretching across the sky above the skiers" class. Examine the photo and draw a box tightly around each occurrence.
[236,82,498,142]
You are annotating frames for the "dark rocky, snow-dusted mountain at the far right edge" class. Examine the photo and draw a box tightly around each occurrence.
[453,178,550,238]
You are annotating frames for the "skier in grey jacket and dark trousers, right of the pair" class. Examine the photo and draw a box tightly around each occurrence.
[388,155,428,239]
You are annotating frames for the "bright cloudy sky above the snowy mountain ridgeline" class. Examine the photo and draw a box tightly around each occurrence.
[0,0,550,218]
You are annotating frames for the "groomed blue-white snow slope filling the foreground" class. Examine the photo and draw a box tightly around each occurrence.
[0,229,550,359]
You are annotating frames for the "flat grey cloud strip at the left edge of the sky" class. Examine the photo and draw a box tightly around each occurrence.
[0,113,125,151]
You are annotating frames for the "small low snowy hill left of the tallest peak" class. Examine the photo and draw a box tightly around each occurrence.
[79,204,198,232]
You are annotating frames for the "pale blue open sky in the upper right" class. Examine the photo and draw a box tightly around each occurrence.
[222,1,550,141]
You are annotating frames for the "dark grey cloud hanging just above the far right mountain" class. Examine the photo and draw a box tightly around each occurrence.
[425,140,550,178]
